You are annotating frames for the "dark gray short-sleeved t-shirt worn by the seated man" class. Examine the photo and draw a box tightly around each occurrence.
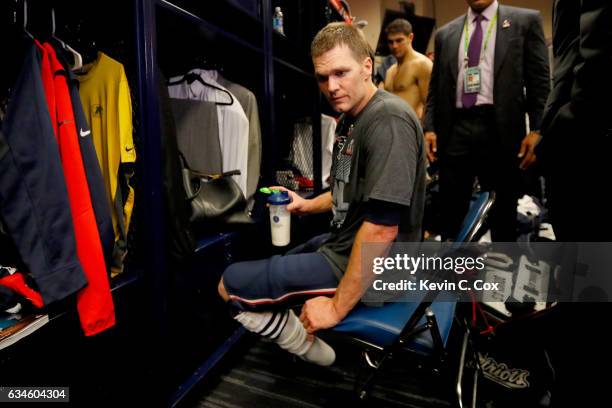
[319,89,425,277]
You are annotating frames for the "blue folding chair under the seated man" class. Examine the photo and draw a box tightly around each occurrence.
[330,192,494,407]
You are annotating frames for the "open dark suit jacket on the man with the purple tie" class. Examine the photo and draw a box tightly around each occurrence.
[424,5,550,154]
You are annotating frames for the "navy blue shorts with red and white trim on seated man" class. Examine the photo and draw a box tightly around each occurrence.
[222,237,339,310]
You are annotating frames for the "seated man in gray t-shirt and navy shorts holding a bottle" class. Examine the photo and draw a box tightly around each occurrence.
[219,23,425,365]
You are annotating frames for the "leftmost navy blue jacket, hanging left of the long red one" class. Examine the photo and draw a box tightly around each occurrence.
[0,43,87,304]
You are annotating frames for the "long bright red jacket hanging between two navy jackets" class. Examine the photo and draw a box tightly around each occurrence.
[37,42,115,336]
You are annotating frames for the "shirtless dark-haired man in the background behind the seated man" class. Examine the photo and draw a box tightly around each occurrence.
[384,18,433,118]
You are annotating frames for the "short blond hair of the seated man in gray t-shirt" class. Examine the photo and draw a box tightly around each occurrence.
[310,22,372,62]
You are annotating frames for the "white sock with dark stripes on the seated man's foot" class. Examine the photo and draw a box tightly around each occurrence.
[234,309,336,366]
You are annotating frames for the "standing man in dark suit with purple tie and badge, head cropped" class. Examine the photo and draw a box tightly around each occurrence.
[424,0,550,241]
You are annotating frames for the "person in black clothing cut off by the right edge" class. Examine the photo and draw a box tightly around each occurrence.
[537,0,612,242]
